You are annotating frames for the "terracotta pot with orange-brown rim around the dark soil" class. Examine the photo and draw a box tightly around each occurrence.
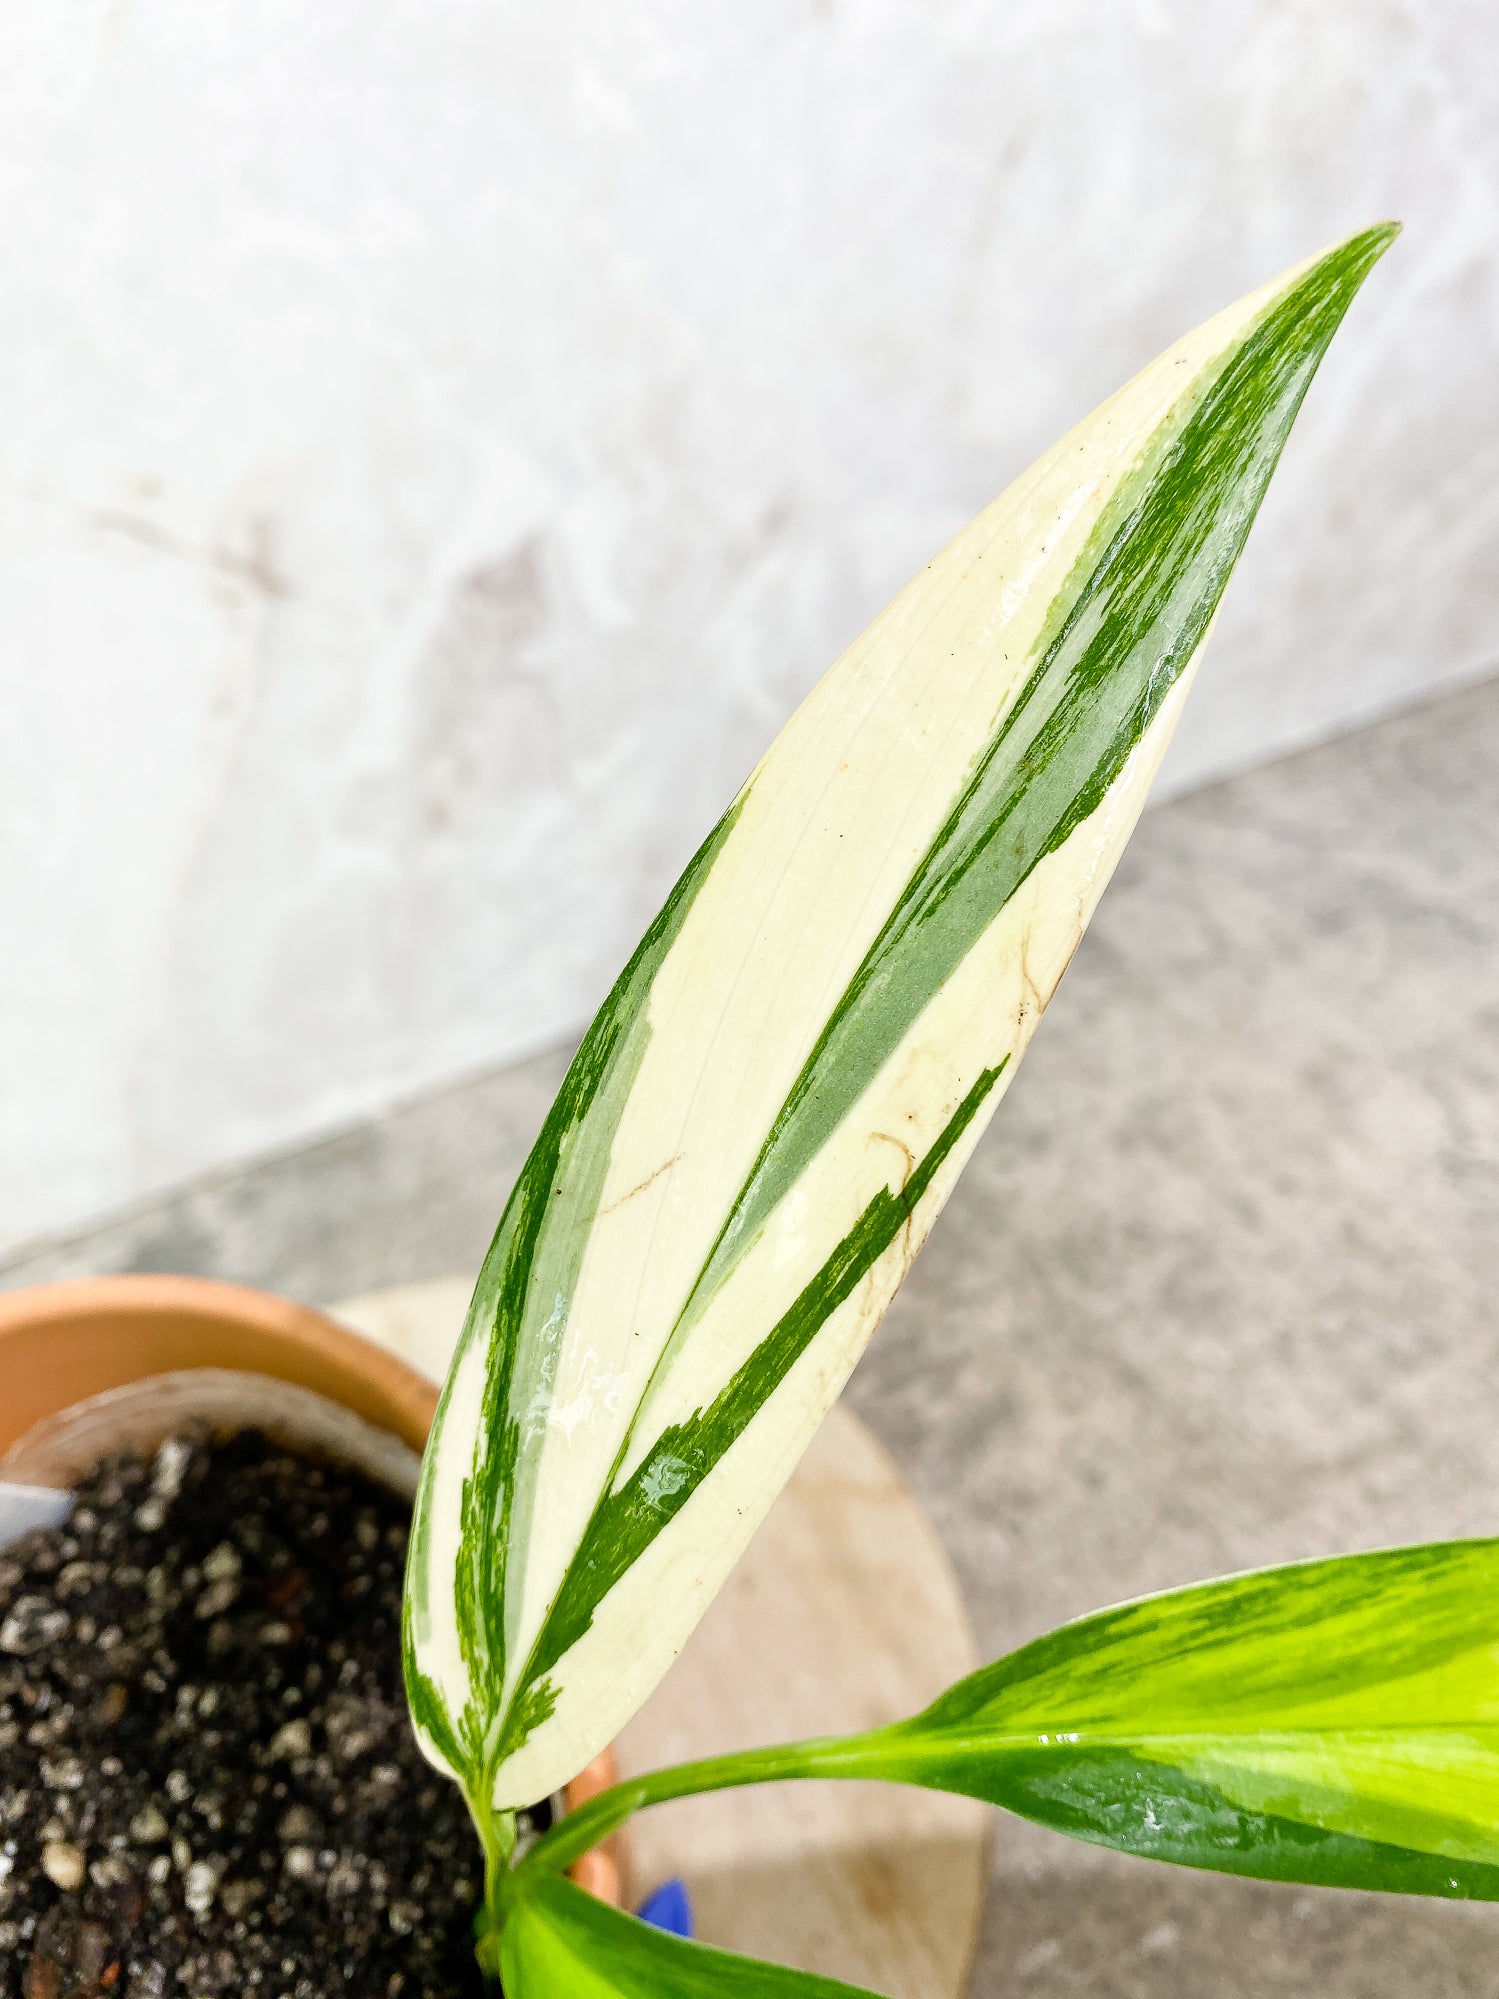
[0,1275,622,1903]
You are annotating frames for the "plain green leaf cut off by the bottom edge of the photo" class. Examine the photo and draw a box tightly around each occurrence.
[500,1873,899,1999]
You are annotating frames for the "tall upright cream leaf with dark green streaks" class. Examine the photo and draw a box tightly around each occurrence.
[406,228,1393,1817]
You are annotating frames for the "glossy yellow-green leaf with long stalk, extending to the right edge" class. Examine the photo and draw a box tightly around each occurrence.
[526,1541,1499,1901]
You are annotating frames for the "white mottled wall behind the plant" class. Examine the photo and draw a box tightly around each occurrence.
[0,0,1499,1243]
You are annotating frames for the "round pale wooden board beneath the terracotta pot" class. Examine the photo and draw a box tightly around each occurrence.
[334,1279,987,1999]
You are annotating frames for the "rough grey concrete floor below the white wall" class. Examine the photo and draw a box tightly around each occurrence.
[11,682,1499,1999]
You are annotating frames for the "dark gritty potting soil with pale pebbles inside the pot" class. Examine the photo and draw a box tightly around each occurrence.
[0,1431,482,1999]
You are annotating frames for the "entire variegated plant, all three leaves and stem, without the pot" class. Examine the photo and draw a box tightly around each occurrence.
[2,228,1471,1999]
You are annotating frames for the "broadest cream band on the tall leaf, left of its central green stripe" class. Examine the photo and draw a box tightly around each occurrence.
[493,260,1315,1673]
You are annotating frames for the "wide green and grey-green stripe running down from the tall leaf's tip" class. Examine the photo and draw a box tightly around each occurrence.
[688,228,1391,1309]
